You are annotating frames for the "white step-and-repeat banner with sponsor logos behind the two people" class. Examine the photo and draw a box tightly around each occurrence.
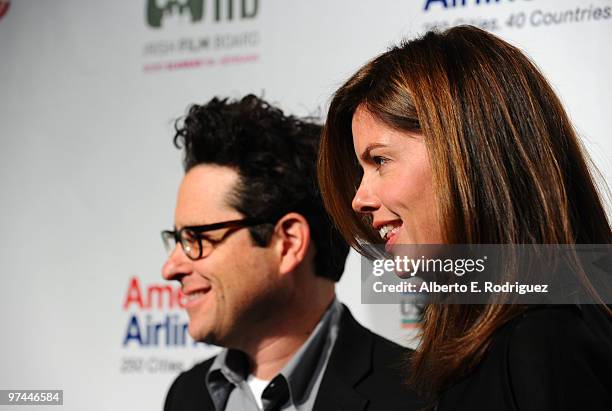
[0,0,612,410]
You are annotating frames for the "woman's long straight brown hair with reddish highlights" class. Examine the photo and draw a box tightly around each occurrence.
[318,26,612,395]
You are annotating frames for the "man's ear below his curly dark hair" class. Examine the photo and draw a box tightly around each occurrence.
[274,213,310,274]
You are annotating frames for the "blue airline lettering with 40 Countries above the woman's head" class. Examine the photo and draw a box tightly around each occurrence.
[422,0,612,32]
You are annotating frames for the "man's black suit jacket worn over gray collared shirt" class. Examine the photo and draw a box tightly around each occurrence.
[164,307,422,411]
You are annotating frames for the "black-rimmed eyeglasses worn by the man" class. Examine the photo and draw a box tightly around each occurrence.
[161,218,273,260]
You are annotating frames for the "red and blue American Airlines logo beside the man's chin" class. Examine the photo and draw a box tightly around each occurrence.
[120,276,206,374]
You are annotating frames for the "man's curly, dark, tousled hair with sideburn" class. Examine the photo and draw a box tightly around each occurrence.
[174,95,349,281]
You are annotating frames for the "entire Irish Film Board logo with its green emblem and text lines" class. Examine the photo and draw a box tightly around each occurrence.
[143,0,261,73]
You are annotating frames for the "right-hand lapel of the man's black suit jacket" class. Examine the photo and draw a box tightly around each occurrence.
[314,306,373,411]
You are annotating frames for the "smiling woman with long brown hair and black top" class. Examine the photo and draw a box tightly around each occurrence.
[318,26,612,411]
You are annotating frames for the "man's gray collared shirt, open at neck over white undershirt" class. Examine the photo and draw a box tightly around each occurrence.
[206,299,343,411]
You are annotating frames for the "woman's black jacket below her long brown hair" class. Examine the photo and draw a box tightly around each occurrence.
[437,305,612,411]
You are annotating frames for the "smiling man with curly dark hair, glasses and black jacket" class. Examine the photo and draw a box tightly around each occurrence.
[162,95,420,411]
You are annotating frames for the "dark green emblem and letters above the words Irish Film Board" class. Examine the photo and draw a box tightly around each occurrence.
[147,0,259,28]
